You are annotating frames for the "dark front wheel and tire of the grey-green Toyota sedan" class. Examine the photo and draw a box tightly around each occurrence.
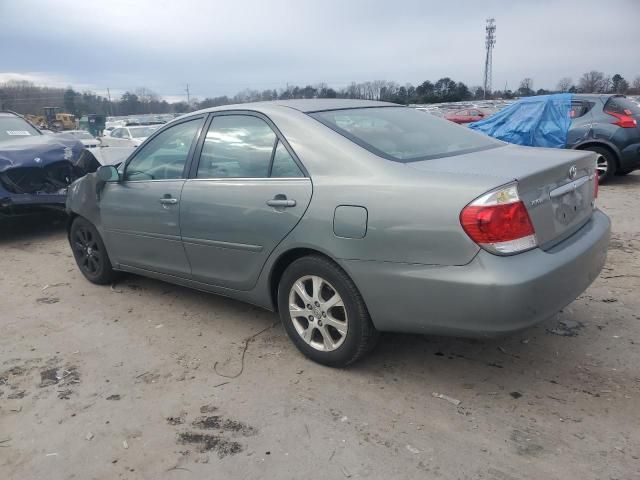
[69,217,117,285]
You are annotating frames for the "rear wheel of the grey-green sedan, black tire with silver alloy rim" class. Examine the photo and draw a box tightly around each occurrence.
[278,255,379,367]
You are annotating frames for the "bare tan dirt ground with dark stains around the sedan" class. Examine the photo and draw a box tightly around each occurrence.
[0,173,640,480]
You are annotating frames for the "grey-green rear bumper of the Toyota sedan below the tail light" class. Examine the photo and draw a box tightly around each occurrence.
[341,210,611,336]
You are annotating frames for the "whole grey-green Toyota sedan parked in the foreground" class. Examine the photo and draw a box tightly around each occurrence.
[67,99,610,366]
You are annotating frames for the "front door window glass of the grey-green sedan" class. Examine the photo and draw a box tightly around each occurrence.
[124,118,202,181]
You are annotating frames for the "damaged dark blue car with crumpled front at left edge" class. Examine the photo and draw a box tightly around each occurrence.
[0,111,99,216]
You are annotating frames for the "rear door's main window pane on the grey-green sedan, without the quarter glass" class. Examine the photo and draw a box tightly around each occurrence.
[196,115,277,178]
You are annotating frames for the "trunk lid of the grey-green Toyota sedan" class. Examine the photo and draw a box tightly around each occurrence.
[407,145,596,250]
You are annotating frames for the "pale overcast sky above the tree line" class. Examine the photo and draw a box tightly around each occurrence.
[0,0,640,100]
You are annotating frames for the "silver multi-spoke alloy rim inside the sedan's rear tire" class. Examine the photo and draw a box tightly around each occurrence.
[289,275,349,352]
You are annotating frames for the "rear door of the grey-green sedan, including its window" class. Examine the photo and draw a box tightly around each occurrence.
[180,112,312,290]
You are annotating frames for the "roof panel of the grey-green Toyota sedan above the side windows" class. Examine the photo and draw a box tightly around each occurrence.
[189,98,404,115]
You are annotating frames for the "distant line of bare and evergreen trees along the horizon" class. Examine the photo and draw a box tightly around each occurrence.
[0,70,640,116]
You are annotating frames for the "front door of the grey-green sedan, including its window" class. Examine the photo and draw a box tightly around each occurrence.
[100,117,203,277]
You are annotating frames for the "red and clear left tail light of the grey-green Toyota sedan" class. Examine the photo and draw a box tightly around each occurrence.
[460,183,538,255]
